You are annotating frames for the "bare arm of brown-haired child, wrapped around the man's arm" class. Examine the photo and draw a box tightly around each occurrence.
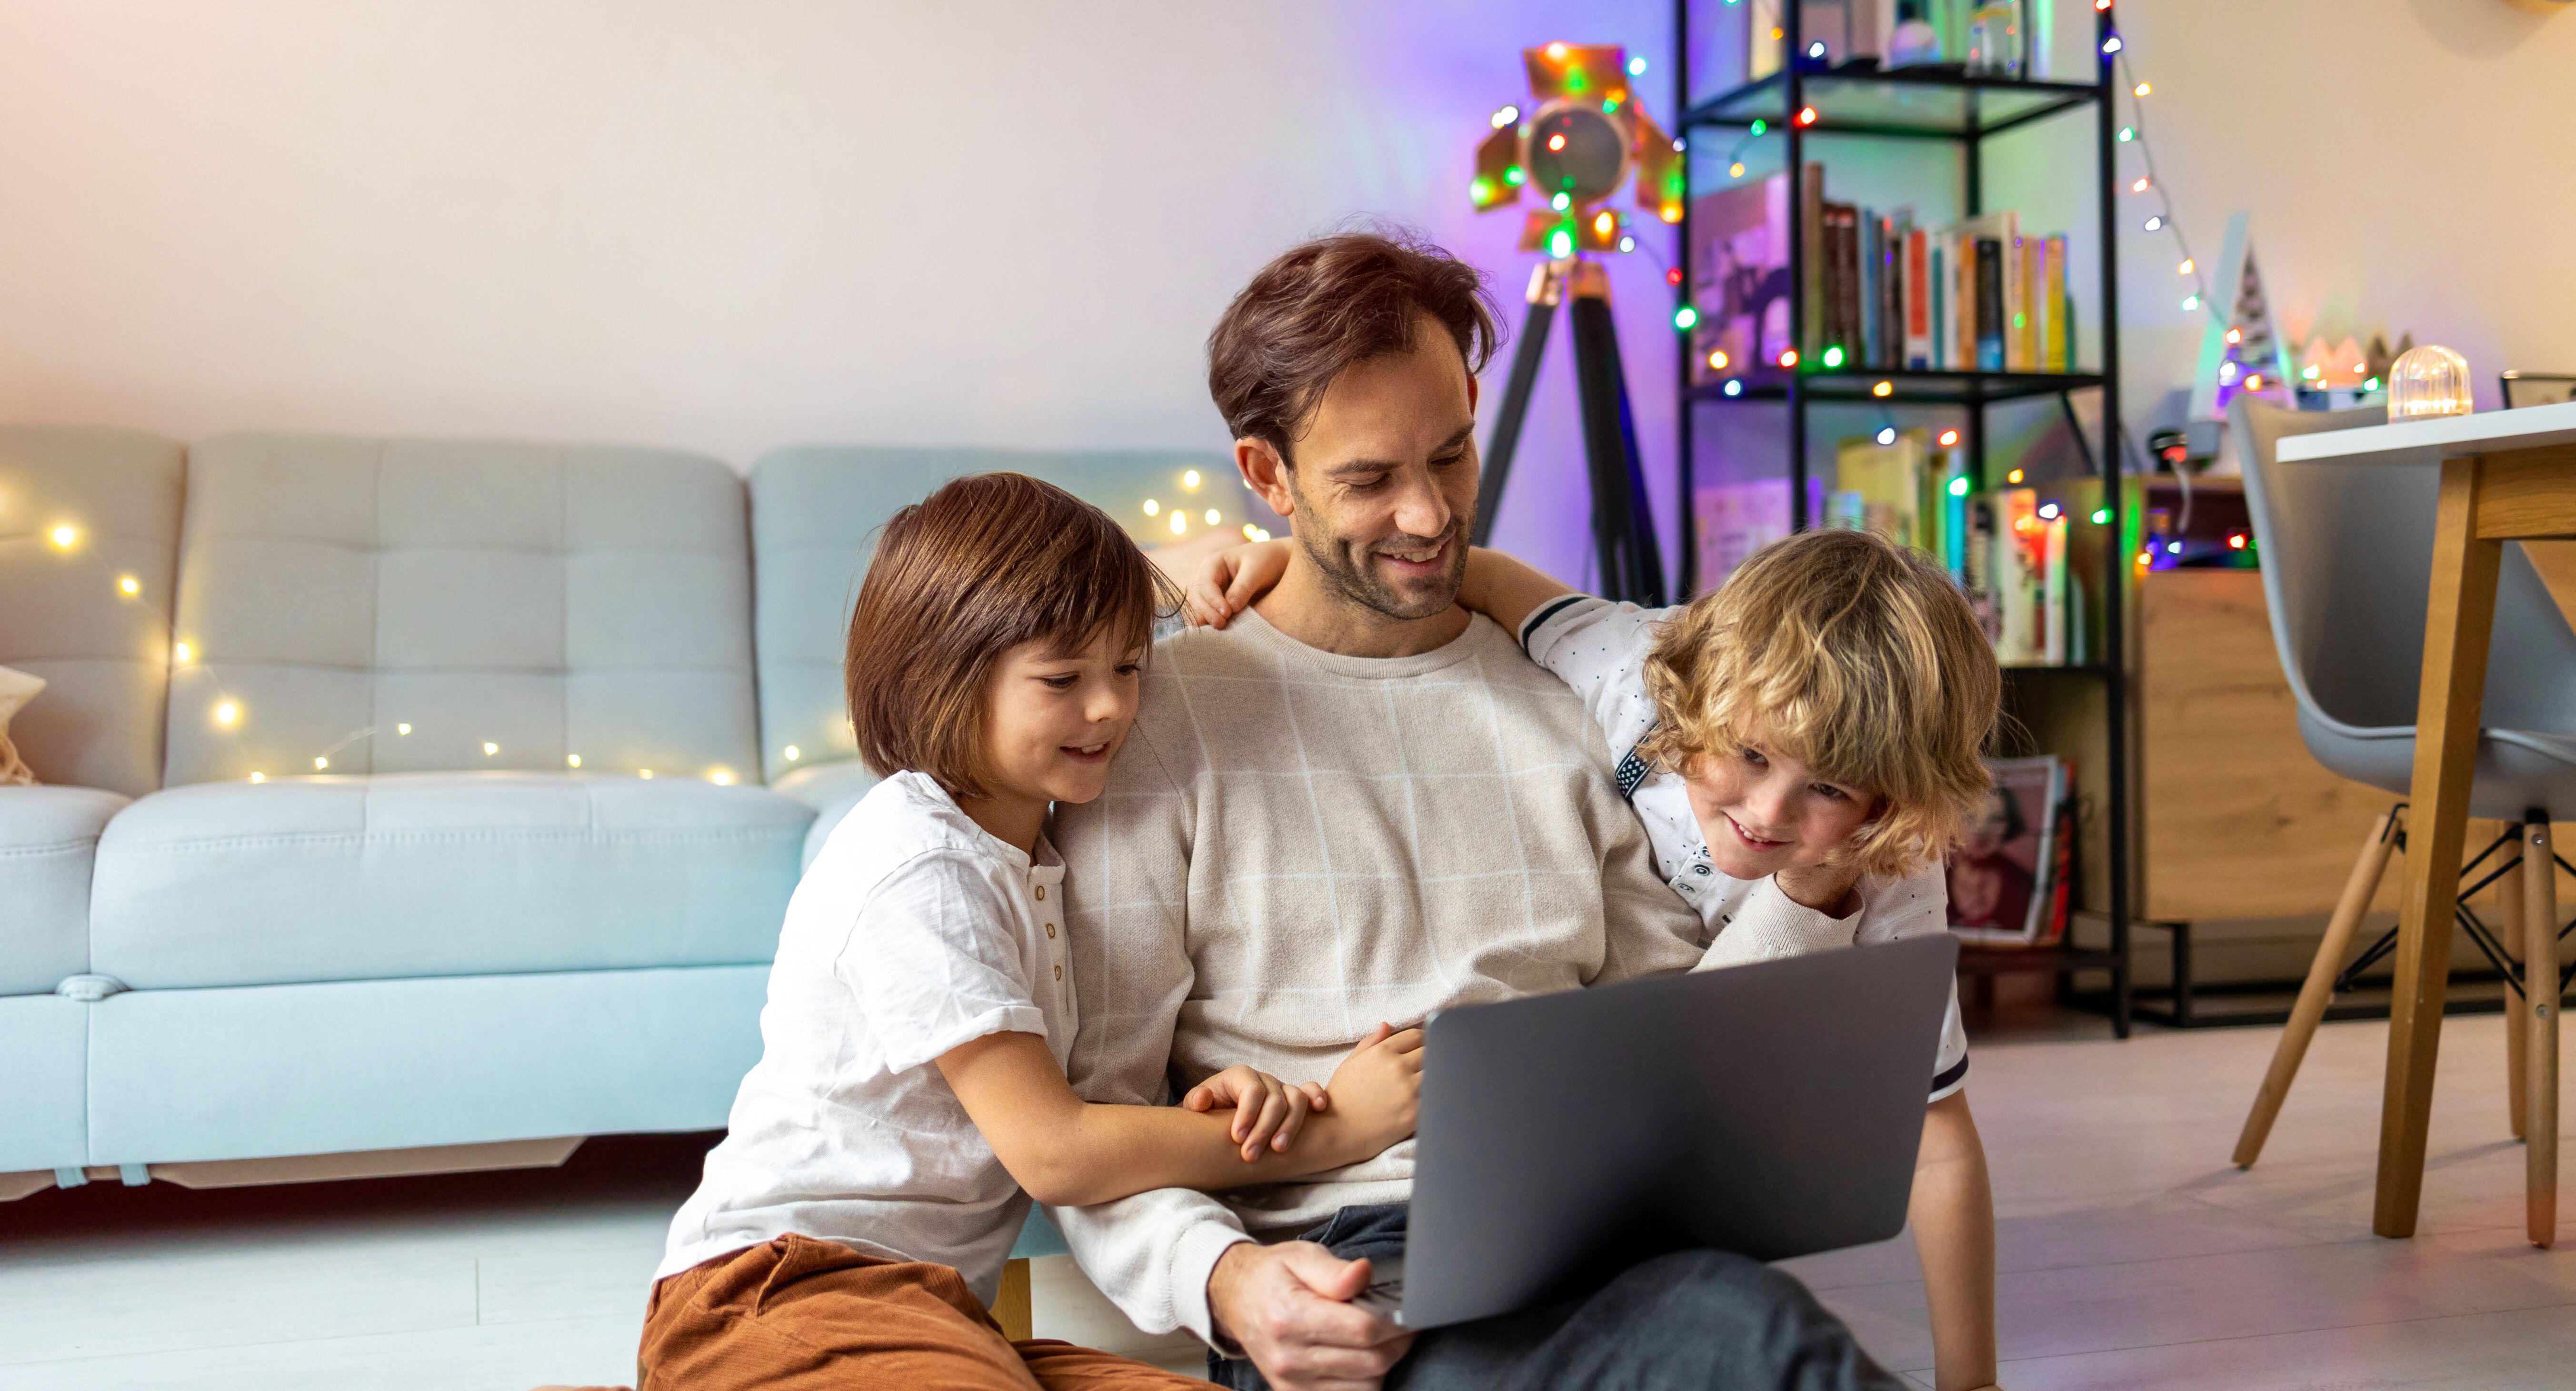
[938,1025,1422,1208]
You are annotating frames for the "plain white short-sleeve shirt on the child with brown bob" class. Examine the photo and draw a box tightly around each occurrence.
[654,773,1079,1303]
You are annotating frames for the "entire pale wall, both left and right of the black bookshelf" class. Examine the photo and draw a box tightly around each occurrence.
[0,0,2576,577]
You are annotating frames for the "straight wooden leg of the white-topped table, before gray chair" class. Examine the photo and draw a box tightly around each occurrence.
[2370,458,2504,1236]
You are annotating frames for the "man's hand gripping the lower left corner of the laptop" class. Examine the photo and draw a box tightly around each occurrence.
[1208,1242,1414,1391]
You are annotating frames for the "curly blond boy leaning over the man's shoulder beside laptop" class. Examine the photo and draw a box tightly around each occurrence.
[1188,520,2002,1391]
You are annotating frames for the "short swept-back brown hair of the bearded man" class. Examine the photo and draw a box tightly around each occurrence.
[1208,229,1497,466]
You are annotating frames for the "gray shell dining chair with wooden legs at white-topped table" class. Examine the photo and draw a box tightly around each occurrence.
[2231,397,2576,1182]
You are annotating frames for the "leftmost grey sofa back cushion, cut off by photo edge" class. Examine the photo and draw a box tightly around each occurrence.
[0,425,180,796]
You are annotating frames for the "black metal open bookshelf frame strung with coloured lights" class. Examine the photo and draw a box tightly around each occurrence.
[1672,0,2136,1038]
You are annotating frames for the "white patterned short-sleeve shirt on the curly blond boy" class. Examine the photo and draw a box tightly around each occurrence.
[1520,595,1968,1100]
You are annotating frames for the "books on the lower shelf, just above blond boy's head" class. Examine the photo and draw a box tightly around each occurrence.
[1824,430,2092,667]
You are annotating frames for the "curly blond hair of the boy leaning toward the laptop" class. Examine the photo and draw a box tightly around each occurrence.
[1638,531,2004,876]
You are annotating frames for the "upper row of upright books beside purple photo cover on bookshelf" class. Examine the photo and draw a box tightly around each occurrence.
[1690,165,2076,381]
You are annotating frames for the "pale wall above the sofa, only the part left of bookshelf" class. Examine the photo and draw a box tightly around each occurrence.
[0,0,1672,587]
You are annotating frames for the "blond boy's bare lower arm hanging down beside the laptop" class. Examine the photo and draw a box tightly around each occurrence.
[1911,1092,1994,1391]
